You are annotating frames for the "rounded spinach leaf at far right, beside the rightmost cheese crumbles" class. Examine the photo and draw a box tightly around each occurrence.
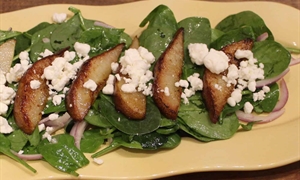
[252,40,291,79]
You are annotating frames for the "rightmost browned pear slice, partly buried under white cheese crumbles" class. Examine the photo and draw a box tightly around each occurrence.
[202,39,253,123]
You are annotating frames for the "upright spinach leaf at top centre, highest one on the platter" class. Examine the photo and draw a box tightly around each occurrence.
[139,5,178,59]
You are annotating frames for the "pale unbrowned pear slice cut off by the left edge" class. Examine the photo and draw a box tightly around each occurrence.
[0,39,16,73]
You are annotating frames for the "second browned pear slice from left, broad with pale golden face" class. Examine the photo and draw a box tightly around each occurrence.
[66,44,124,121]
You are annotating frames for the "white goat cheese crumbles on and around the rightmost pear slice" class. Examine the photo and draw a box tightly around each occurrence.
[188,43,270,113]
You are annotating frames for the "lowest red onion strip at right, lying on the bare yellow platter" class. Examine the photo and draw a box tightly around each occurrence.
[235,108,285,124]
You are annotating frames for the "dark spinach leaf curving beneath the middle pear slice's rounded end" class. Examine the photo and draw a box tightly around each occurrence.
[100,94,161,135]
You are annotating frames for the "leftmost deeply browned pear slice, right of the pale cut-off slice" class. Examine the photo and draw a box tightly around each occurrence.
[13,50,65,134]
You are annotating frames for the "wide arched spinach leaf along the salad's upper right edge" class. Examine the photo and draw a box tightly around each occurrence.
[216,11,274,40]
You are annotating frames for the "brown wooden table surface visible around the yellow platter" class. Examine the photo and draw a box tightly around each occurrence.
[0,0,300,180]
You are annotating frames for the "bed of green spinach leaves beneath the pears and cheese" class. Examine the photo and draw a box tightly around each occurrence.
[0,5,291,176]
